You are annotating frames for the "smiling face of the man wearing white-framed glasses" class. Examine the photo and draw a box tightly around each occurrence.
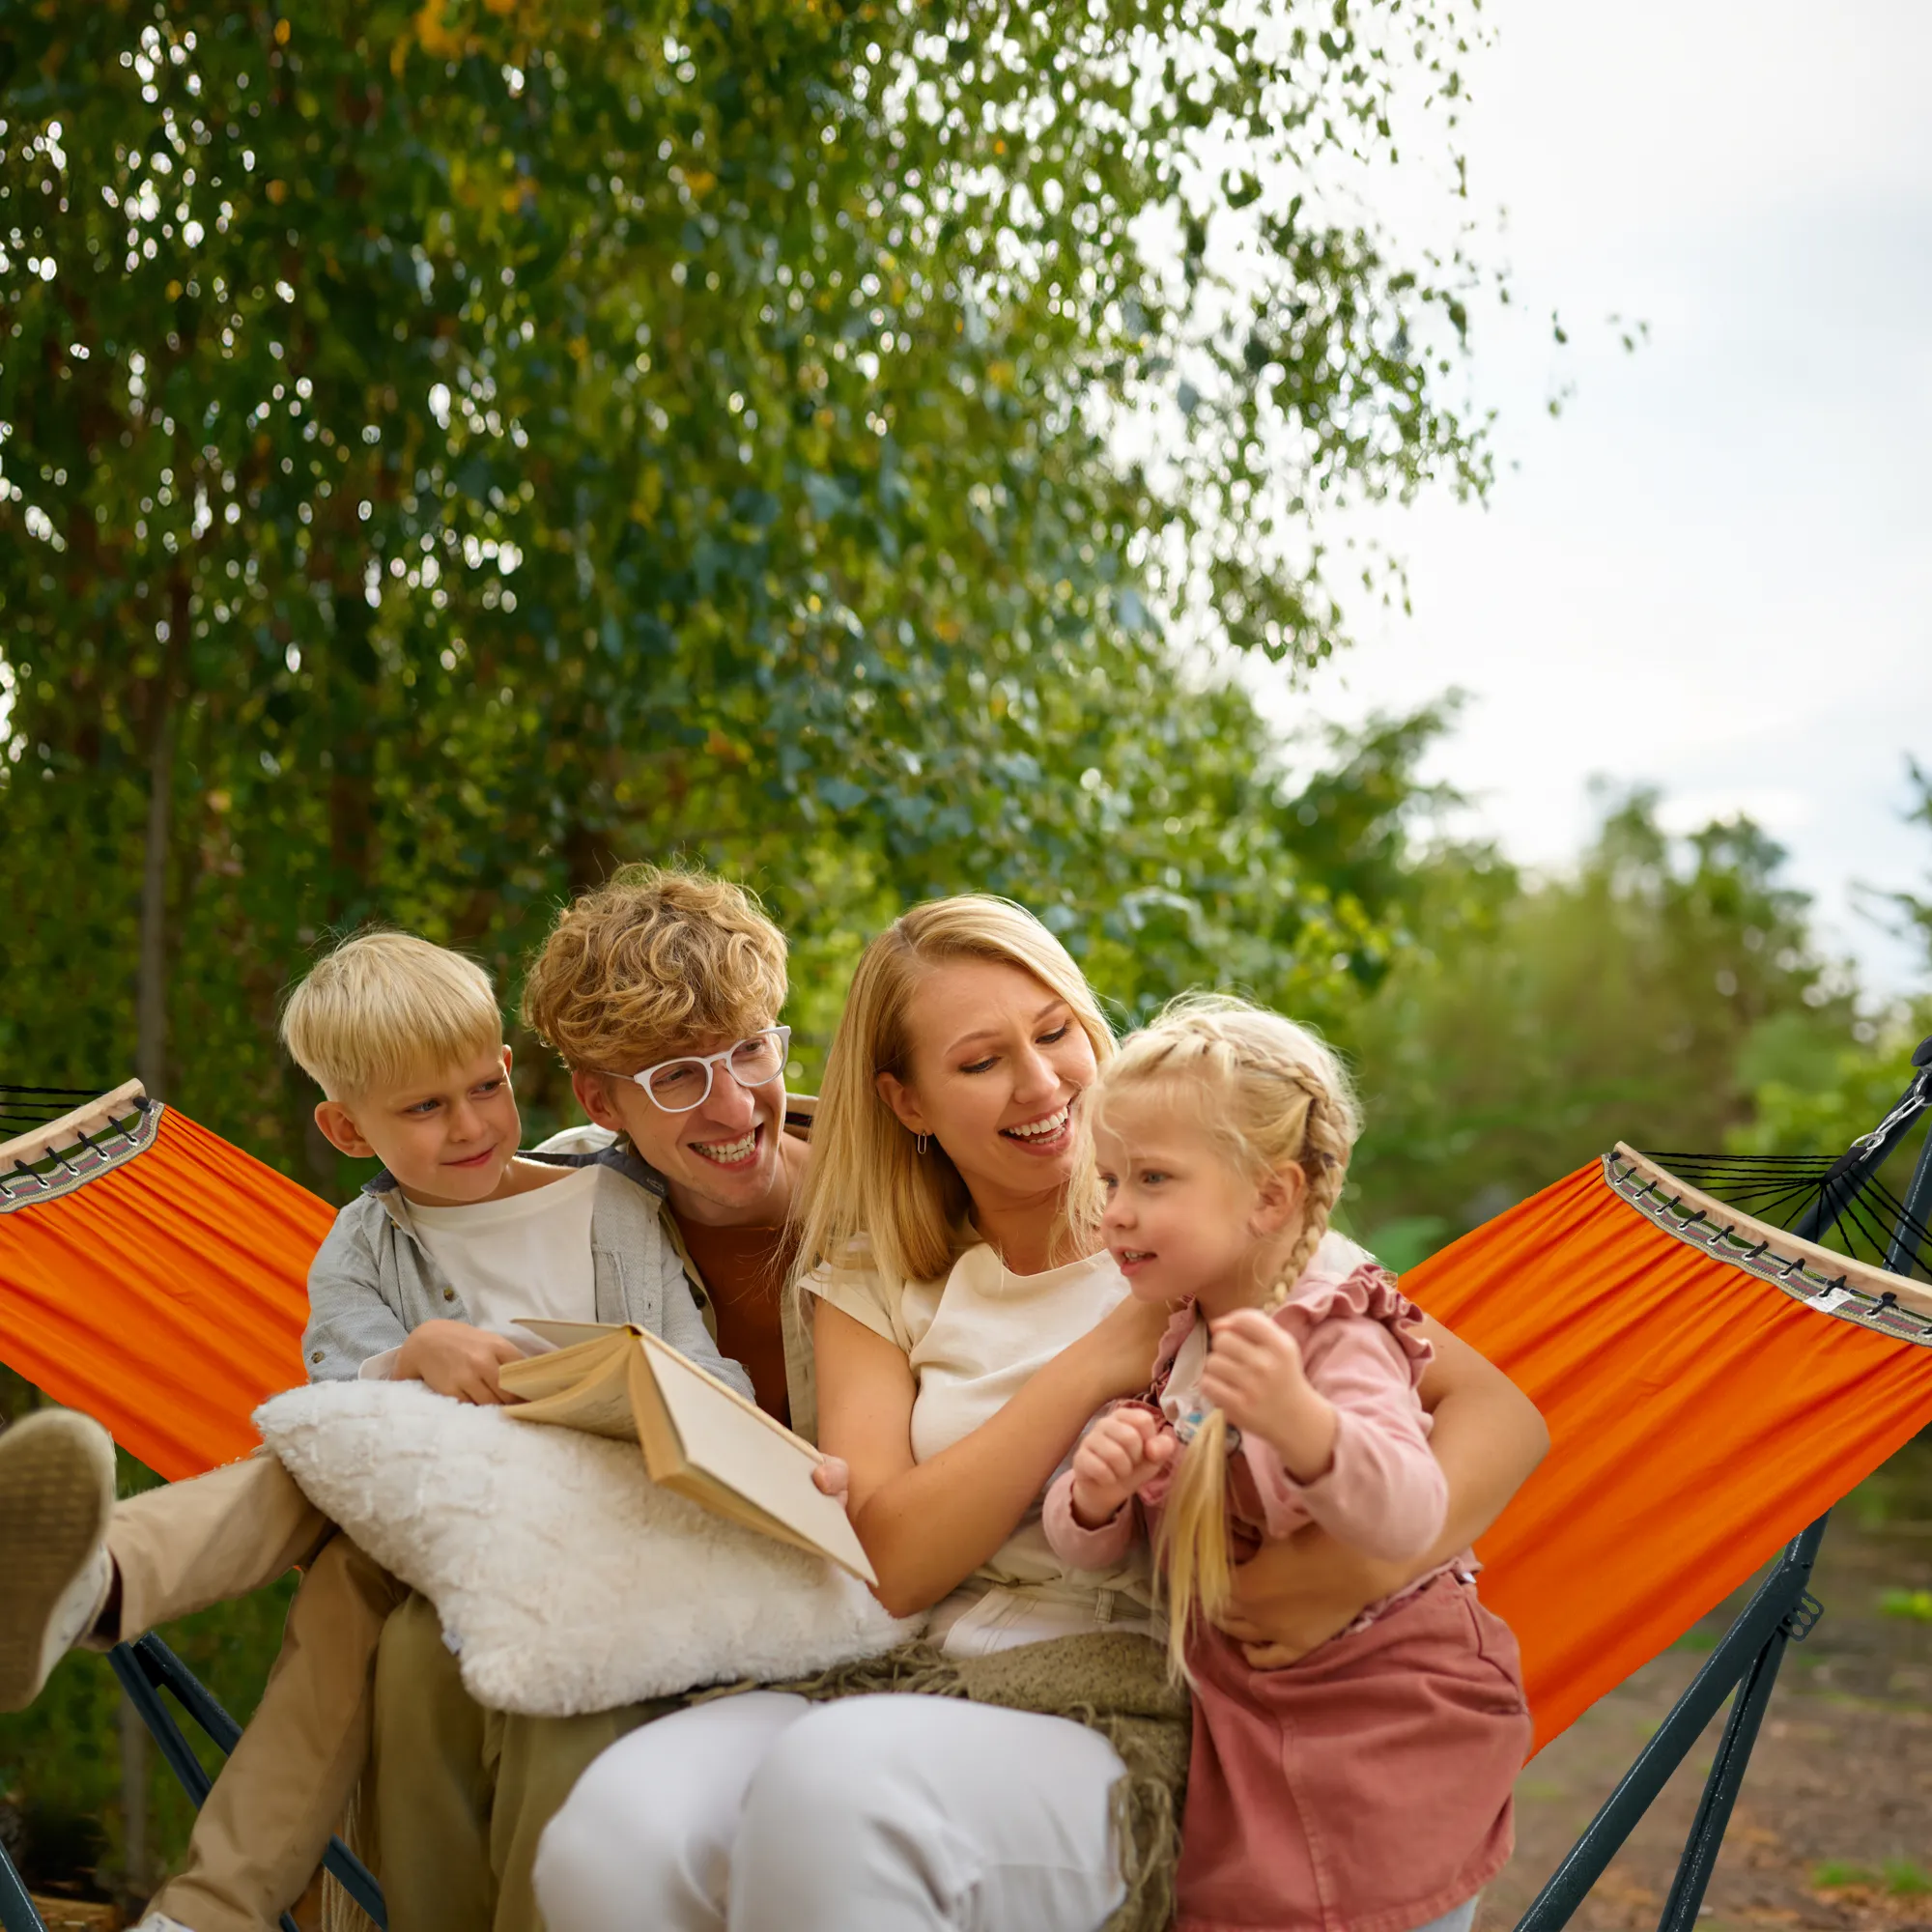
[570,1034,786,1227]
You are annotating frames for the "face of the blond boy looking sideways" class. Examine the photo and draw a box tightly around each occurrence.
[315,1047,522,1208]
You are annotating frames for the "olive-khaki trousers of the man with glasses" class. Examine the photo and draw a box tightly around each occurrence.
[369,1596,676,1932]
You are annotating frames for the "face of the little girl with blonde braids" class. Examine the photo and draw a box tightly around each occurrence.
[1094,1090,1302,1314]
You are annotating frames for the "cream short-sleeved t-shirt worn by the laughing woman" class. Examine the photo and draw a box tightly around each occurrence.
[804,1242,1153,1656]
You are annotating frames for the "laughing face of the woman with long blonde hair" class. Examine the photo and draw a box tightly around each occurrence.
[879,958,1097,1206]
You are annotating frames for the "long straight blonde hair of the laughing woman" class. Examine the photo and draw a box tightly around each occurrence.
[798,893,1113,1281]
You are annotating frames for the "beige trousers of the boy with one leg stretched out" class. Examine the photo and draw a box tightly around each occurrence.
[99,1455,404,1932]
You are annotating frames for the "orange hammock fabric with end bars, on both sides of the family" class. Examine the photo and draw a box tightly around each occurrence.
[0,1086,1932,1745]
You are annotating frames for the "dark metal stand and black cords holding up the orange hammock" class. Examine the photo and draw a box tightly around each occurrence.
[0,1039,1932,1932]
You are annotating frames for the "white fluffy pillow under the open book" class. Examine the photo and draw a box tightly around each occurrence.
[255,1381,912,1718]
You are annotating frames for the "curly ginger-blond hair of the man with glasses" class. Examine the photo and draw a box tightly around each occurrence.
[524,866,784,1074]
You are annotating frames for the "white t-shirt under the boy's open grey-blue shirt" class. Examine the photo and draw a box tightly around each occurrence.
[361,1167,603,1381]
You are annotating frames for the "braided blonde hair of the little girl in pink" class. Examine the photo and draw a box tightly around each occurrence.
[1070,993,1360,1673]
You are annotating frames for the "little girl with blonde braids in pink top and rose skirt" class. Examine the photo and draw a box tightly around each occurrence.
[1045,997,1530,1932]
